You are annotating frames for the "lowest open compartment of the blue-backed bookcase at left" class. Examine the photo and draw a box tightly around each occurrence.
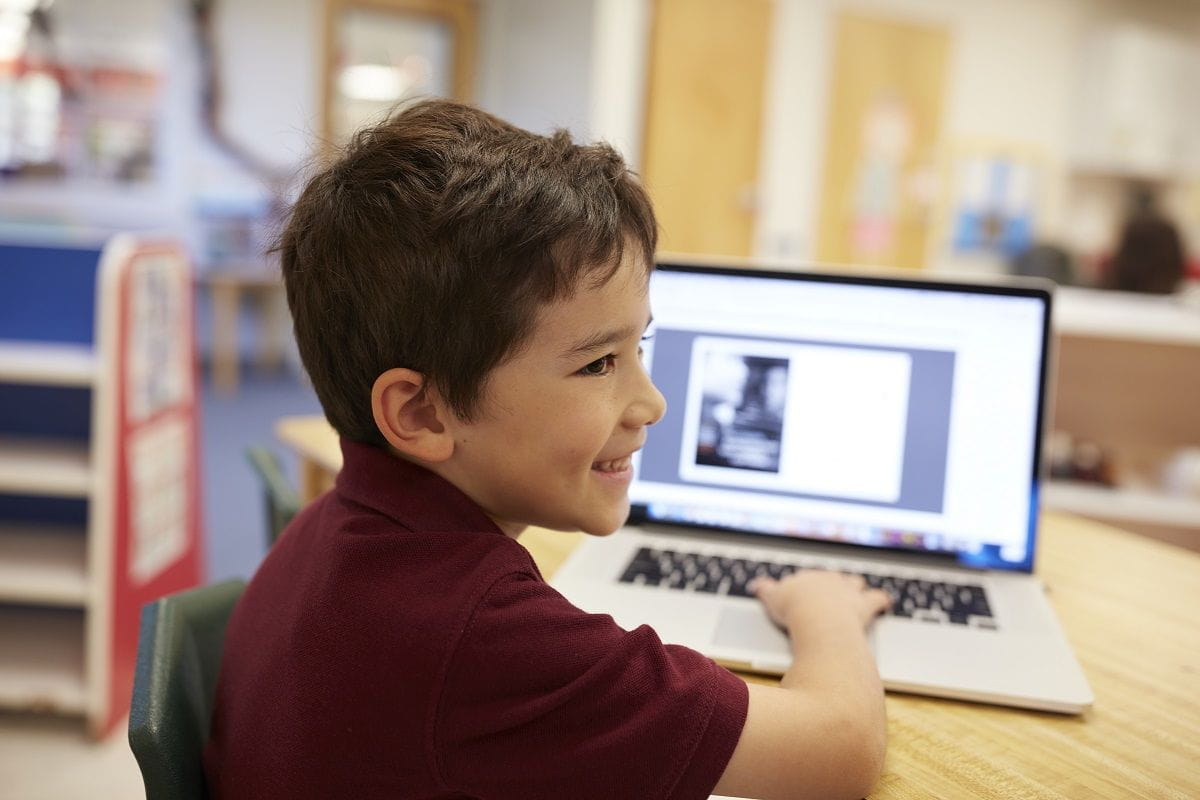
[0,607,86,714]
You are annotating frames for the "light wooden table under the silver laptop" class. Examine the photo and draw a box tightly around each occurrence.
[277,417,1200,800]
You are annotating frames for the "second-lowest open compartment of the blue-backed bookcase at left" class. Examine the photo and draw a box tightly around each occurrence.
[0,523,88,608]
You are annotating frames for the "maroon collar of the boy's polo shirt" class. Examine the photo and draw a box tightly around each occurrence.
[337,439,504,536]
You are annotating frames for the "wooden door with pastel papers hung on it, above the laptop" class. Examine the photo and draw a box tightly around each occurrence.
[817,13,949,269]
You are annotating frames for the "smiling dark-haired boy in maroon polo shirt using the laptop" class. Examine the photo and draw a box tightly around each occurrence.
[205,101,887,800]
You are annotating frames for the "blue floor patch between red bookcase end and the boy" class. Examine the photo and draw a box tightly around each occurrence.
[200,368,320,582]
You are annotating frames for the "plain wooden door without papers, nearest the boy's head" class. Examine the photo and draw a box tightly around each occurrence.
[642,0,773,255]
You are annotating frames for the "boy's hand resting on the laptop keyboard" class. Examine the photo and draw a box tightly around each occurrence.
[750,570,892,632]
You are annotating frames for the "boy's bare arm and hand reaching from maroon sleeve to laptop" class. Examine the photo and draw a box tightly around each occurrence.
[714,571,888,800]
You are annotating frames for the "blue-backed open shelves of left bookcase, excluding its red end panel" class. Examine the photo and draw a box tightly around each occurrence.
[0,245,101,715]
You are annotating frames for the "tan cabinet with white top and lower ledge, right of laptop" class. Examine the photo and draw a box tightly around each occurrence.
[1044,289,1200,549]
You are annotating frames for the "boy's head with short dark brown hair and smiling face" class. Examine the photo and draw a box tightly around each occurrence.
[280,101,662,533]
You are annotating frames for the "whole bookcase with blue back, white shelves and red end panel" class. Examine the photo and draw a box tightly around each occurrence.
[0,235,200,735]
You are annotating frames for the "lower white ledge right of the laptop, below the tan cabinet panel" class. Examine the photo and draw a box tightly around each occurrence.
[1042,481,1200,533]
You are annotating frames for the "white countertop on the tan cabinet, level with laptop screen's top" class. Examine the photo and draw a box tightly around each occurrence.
[1054,287,1200,347]
